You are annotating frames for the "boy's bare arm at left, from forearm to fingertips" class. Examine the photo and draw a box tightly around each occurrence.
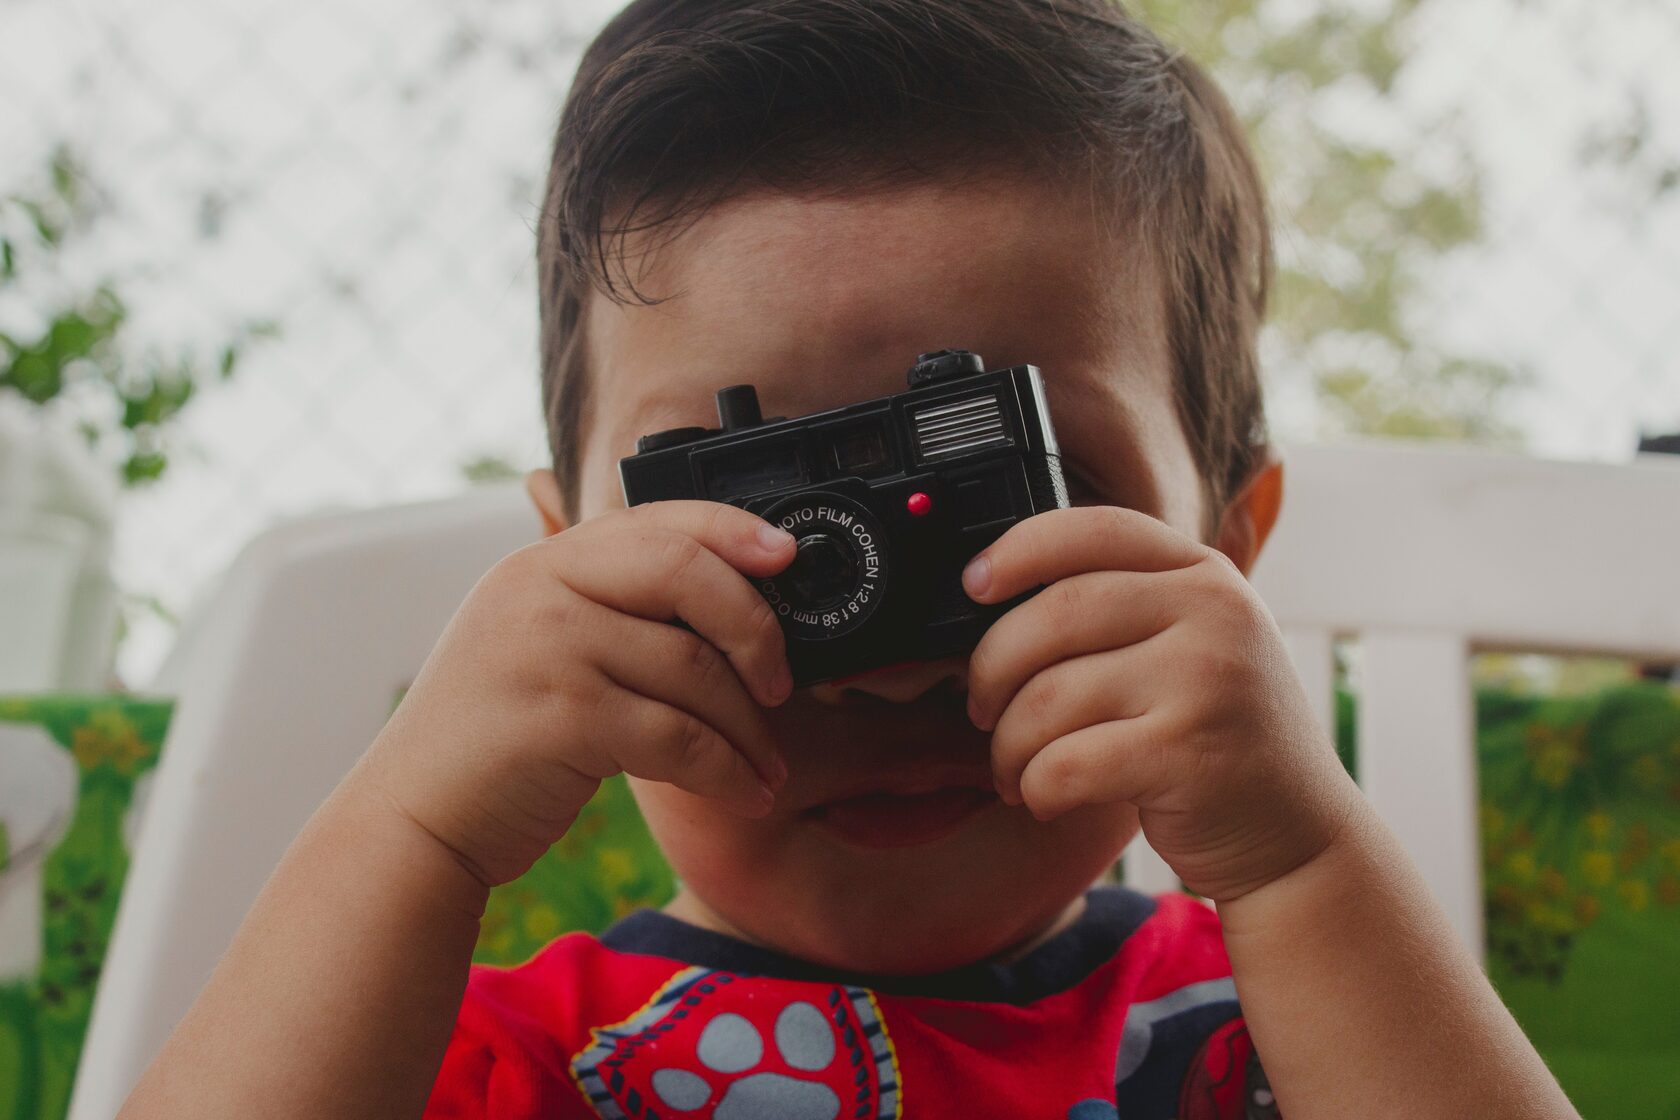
[121,502,795,1120]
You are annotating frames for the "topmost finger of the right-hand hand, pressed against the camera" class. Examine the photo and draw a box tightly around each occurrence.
[963,505,1211,603]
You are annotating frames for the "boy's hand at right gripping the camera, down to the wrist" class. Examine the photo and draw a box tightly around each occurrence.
[963,505,1359,902]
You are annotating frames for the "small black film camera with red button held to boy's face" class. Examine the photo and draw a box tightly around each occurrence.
[618,349,1068,685]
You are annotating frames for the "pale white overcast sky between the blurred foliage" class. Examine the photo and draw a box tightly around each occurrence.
[0,0,1680,682]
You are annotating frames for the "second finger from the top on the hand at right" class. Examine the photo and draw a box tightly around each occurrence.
[968,571,1184,730]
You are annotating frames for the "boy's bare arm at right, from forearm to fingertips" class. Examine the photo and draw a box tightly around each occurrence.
[964,507,1576,1120]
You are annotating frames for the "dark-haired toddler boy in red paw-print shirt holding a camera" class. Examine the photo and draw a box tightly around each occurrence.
[124,0,1574,1120]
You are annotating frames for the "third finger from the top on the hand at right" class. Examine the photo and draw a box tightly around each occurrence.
[991,641,1152,804]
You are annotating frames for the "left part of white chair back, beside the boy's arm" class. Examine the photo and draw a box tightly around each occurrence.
[69,485,539,1120]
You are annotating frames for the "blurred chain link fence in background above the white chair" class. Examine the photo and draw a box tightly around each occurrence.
[0,0,1680,680]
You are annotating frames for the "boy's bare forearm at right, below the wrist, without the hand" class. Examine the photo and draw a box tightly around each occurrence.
[1220,808,1576,1120]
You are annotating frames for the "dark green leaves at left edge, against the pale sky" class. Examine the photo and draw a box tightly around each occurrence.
[0,146,277,485]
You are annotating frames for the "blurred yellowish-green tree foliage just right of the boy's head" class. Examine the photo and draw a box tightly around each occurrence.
[1127,0,1529,445]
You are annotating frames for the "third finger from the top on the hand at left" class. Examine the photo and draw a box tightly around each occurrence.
[585,608,788,789]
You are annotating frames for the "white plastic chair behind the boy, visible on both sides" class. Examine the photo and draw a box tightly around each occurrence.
[71,447,1680,1120]
